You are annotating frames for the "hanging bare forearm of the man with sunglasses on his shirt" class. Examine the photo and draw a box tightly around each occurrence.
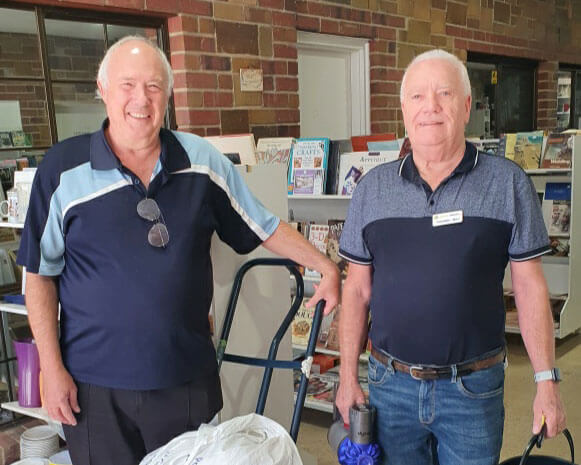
[26,273,63,371]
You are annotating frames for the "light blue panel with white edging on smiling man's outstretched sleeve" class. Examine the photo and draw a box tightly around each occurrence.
[173,132,280,241]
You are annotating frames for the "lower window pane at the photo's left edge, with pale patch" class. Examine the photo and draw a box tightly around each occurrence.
[0,79,51,148]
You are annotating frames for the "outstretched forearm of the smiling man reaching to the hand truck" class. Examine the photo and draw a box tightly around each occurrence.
[262,220,338,276]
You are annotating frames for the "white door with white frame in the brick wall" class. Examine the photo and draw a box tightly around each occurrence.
[297,32,370,139]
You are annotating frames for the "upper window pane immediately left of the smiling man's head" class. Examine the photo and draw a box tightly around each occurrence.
[45,19,105,81]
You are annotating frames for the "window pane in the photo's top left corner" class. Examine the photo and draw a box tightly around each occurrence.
[0,8,42,78]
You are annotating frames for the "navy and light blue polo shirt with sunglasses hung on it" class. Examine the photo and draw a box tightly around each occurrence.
[18,121,279,390]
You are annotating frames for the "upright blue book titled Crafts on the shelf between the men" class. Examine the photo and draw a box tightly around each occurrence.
[288,137,329,195]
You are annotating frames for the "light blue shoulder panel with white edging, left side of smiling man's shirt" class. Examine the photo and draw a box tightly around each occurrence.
[38,162,131,276]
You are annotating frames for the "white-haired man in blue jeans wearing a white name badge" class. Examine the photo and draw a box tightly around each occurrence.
[337,50,565,465]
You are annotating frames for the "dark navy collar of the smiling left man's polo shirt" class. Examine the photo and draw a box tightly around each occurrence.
[90,118,190,173]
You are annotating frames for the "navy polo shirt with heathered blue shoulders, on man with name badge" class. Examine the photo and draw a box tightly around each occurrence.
[339,143,550,365]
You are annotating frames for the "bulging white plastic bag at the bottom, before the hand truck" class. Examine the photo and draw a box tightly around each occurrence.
[140,413,302,465]
